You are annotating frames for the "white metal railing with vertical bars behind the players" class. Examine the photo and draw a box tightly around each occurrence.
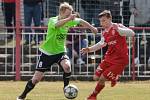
[0,27,150,78]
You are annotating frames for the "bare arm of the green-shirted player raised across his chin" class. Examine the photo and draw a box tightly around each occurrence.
[55,14,76,27]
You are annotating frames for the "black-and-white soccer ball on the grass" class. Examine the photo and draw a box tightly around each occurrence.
[64,84,78,99]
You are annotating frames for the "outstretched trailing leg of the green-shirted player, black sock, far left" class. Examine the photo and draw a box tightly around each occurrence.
[18,71,43,100]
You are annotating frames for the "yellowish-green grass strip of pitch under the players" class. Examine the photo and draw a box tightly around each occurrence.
[0,81,150,100]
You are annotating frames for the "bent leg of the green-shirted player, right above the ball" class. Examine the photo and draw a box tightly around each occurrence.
[59,55,71,87]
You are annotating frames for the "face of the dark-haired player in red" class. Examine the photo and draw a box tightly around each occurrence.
[99,16,111,28]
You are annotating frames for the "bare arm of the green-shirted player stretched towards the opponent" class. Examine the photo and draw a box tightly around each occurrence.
[80,19,98,34]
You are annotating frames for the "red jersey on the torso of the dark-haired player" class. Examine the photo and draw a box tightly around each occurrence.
[102,26,128,64]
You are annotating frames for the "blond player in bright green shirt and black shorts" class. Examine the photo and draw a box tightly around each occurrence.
[17,2,98,100]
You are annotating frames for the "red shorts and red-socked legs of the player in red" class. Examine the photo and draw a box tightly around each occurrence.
[88,62,125,100]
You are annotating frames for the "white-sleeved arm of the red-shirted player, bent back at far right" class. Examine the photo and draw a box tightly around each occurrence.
[113,24,135,36]
